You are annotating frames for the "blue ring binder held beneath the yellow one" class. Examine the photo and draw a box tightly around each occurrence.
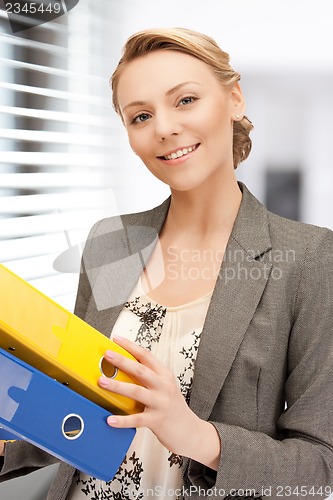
[0,349,136,481]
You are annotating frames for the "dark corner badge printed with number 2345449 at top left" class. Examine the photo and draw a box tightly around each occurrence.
[0,0,79,33]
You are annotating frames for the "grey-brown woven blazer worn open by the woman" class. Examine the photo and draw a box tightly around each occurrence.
[1,183,333,500]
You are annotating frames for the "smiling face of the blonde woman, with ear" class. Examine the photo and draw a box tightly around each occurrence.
[117,50,244,191]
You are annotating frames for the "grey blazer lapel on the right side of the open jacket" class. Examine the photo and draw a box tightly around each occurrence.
[190,183,271,419]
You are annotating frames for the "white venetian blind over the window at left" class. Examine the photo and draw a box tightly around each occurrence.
[0,0,120,310]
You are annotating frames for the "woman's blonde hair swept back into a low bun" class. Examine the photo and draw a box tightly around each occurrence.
[110,28,253,168]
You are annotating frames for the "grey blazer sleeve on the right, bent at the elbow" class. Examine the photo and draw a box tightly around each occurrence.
[185,229,333,500]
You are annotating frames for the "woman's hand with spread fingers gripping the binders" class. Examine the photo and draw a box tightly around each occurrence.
[99,337,220,469]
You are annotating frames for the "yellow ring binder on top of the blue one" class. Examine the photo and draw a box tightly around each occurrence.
[0,264,143,414]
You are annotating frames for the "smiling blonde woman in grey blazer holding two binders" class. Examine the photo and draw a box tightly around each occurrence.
[2,28,333,500]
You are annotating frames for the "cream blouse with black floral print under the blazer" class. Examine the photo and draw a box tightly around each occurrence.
[67,279,212,500]
